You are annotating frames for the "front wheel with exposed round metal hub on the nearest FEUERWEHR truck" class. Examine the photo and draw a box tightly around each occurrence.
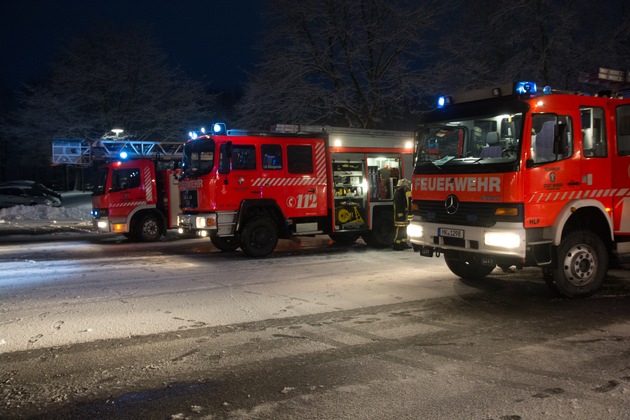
[543,230,608,298]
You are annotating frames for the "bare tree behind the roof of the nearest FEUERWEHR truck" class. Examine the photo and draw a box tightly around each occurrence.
[435,0,628,91]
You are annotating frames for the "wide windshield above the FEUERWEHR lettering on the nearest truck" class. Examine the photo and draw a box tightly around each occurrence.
[416,113,523,170]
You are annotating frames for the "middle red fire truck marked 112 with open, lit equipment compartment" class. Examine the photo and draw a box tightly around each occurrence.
[179,125,413,257]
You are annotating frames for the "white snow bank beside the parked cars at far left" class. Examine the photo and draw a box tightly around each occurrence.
[0,191,92,233]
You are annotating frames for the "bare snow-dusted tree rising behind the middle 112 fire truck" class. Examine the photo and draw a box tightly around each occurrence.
[239,0,448,128]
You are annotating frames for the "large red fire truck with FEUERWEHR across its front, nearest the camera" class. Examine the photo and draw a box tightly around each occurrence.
[407,78,630,297]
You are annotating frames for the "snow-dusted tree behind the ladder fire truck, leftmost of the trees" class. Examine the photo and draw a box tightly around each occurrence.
[4,28,212,177]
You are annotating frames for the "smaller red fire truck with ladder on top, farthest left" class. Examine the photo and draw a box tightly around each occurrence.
[90,141,183,242]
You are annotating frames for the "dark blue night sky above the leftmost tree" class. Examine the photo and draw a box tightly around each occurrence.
[0,0,264,89]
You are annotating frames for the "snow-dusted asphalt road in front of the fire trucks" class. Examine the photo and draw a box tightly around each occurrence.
[0,235,630,419]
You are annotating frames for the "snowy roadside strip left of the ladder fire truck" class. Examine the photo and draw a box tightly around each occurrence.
[0,191,92,236]
